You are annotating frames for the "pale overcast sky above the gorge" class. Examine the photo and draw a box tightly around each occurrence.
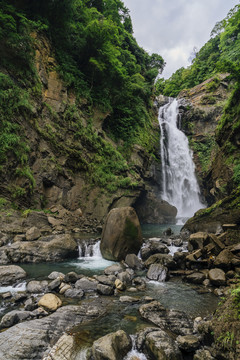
[123,0,239,78]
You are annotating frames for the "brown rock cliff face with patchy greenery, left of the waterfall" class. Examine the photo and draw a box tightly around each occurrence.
[0,33,176,225]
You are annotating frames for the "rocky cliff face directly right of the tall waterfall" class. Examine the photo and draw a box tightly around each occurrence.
[180,74,240,232]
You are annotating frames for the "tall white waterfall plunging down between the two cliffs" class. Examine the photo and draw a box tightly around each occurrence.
[158,99,205,218]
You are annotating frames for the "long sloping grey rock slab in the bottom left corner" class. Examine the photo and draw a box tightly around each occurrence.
[0,299,106,360]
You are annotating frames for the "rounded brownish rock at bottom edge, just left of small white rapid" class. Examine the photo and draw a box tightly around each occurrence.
[92,330,132,360]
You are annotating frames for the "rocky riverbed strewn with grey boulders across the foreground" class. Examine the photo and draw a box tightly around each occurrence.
[0,221,240,360]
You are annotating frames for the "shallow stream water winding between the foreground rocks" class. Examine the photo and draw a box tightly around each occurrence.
[0,225,218,360]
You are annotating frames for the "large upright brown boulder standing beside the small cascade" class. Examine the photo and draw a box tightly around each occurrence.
[100,207,142,261]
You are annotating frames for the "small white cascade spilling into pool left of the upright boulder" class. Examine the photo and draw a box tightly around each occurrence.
[77,241,115,270]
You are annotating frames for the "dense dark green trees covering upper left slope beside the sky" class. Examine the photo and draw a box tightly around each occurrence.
[6,0,164,144]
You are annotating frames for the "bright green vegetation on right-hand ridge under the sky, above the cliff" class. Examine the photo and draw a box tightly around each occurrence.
[156,5,240,96]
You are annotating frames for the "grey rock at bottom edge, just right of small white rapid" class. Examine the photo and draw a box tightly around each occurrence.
[144,329,182,360]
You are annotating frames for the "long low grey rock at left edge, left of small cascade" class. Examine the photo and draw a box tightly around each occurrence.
[0,234,78,263]
